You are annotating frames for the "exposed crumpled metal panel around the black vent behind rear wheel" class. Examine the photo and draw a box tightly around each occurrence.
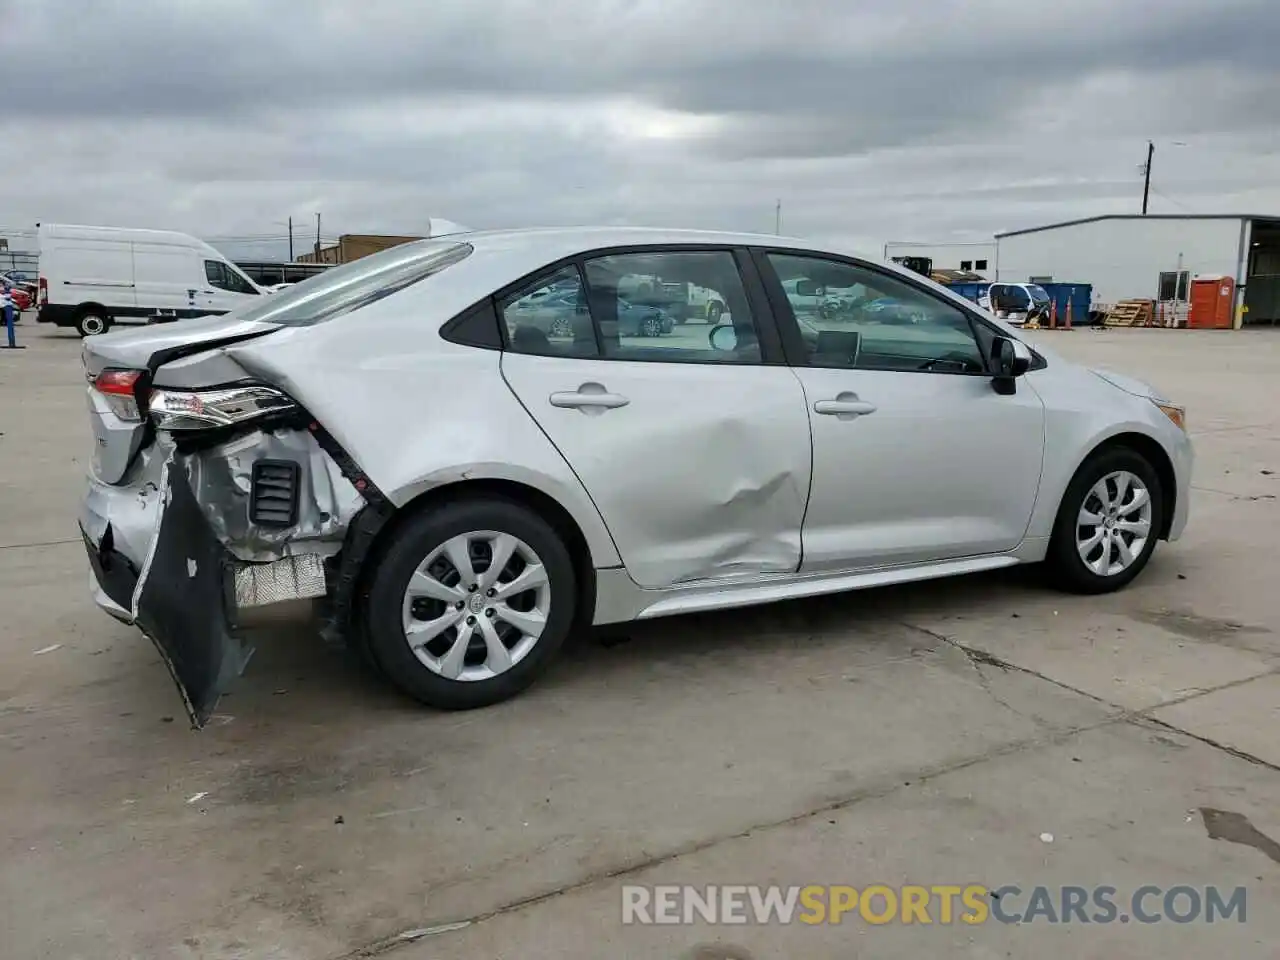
[180,429,365,563]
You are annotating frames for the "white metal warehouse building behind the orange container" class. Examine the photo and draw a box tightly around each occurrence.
[995,214,1280,326]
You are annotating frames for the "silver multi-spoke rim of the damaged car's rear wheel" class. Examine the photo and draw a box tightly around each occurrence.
[402,530,552,682]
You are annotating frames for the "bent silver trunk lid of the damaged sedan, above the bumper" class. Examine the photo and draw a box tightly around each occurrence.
[81,316,279,484]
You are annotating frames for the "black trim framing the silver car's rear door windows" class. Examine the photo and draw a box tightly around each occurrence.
[481,242,790,367]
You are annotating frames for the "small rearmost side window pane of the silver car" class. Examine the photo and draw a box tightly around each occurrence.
[499,266,600,357]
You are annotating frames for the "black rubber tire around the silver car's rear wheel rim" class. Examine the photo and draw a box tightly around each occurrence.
[364,499,577,710]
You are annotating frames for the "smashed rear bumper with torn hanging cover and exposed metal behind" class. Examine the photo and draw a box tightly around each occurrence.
[79,430,364,727]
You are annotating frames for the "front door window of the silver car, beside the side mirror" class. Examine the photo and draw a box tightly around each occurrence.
[768,253,995,374]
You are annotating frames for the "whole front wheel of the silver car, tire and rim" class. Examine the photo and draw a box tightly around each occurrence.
[1048,447,1164,594]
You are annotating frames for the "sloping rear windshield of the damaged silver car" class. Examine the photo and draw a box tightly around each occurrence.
[237,239,472,326]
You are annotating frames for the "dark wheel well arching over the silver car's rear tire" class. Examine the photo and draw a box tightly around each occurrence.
[357,480,595,631]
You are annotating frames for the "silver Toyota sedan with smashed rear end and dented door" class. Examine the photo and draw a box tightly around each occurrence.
[81,229,1192,726]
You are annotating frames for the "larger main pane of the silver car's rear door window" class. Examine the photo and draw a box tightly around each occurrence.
[584,250,762,364]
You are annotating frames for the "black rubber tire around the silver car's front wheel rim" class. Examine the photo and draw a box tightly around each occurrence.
[1047,447,1165,594]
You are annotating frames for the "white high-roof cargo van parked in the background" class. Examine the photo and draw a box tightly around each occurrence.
[37,224,262,337]
